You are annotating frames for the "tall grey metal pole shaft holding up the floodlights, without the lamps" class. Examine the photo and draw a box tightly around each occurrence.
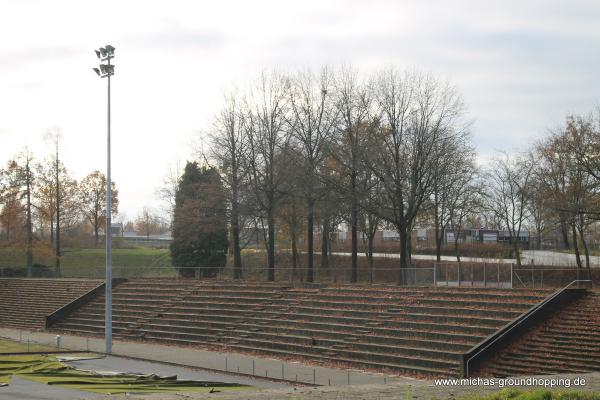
[104,56,112,354]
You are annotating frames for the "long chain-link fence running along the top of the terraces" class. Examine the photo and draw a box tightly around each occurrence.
[0,262,600,288]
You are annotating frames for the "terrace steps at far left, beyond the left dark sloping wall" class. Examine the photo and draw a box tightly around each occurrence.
[0,278,102,330]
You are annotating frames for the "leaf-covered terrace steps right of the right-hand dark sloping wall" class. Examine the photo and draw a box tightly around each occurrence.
[478,292,600,377]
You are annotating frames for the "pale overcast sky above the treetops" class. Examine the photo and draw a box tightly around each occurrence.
[0,0,600,218]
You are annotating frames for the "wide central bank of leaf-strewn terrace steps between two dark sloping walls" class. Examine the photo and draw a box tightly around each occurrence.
[52,280,549,376]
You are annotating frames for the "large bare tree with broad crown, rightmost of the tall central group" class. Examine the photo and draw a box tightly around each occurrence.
[367,68,466,281]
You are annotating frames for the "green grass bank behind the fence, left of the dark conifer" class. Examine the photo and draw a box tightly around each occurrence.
[0,247,177,278]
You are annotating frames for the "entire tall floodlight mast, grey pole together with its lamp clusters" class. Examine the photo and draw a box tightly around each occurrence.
[93,45,115,354]
